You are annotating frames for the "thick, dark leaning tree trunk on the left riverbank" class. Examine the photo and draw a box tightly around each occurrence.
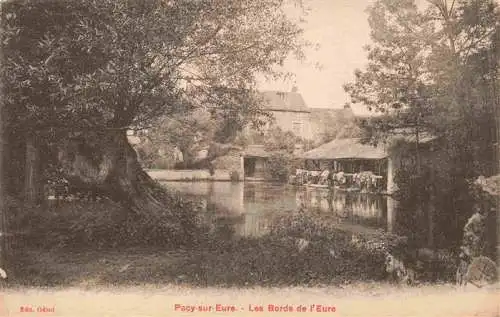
[58,131,168,215]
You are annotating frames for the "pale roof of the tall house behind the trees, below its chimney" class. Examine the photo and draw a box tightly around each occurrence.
[261,91,310,112]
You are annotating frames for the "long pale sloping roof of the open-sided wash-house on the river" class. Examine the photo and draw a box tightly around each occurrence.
[300,139,388,160]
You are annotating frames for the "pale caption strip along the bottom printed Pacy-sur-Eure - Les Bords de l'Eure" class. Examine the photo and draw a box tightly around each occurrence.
[0,284,500,317]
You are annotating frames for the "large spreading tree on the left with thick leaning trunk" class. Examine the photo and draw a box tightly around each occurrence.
[2,0,304,212]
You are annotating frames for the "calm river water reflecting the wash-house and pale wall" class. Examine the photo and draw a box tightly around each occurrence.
[164,182,395,236]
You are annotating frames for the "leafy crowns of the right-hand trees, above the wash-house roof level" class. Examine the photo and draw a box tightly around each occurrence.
[344,0,500,153]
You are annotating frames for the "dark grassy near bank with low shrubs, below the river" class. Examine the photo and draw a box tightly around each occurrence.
[2,191,460,286]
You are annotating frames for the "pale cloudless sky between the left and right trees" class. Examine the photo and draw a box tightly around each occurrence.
[261,0,372,112]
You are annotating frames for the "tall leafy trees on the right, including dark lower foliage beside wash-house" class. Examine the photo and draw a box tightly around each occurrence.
[345,0,500,247]
